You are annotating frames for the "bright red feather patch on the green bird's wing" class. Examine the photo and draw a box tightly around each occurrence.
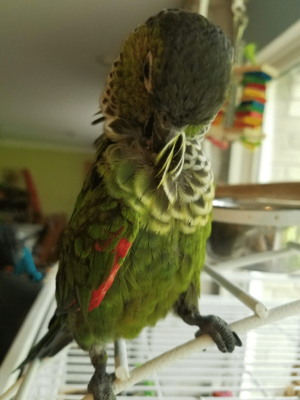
[89,238,132,312]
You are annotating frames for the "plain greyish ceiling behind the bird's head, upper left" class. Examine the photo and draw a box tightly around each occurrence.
[0,0,183,148]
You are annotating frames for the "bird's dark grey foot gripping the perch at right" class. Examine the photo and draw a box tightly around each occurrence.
[195,315,242,353]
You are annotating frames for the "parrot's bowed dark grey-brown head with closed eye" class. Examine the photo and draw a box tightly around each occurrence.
[101,9,232,152]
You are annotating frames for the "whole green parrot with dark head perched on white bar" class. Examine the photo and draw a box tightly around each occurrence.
[19,9,241,400]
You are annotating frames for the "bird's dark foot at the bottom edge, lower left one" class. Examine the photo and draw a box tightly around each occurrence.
[88,365,116,400]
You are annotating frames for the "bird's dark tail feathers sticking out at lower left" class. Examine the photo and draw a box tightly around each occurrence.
[16,315,73,369]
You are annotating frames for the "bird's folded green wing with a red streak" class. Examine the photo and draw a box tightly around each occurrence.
[56,139,139,315]
